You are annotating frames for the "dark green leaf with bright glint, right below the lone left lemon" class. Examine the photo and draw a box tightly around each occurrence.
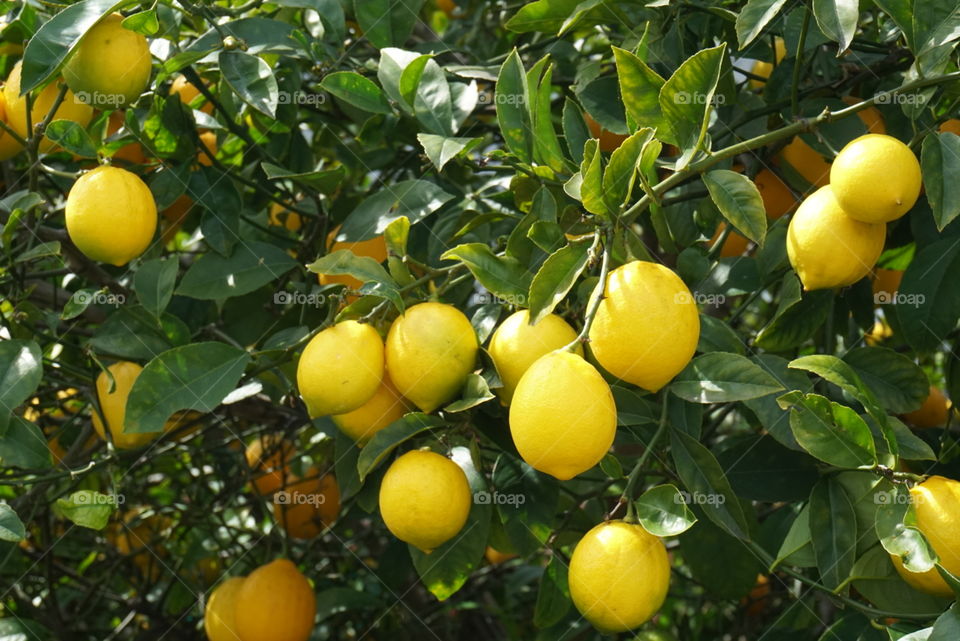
[177,242,297,300]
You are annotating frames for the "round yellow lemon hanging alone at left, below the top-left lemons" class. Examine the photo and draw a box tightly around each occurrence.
[66,165,157,267]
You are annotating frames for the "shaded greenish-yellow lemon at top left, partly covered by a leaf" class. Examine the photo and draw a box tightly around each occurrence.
[63,13,151,108]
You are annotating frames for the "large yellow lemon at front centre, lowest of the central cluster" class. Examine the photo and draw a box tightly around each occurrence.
[510,351,617,481]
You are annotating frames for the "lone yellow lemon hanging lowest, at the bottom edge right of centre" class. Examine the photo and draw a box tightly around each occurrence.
[569,521,670,632]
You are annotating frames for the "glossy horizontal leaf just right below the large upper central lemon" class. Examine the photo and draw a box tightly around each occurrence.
[670,352,783,403]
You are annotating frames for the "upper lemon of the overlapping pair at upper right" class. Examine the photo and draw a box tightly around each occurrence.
[830,134,921,223]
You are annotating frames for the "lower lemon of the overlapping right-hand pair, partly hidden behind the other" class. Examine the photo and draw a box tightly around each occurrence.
[787,185,887,290]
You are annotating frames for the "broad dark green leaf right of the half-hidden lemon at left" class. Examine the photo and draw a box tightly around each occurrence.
[124,342,250,434]
